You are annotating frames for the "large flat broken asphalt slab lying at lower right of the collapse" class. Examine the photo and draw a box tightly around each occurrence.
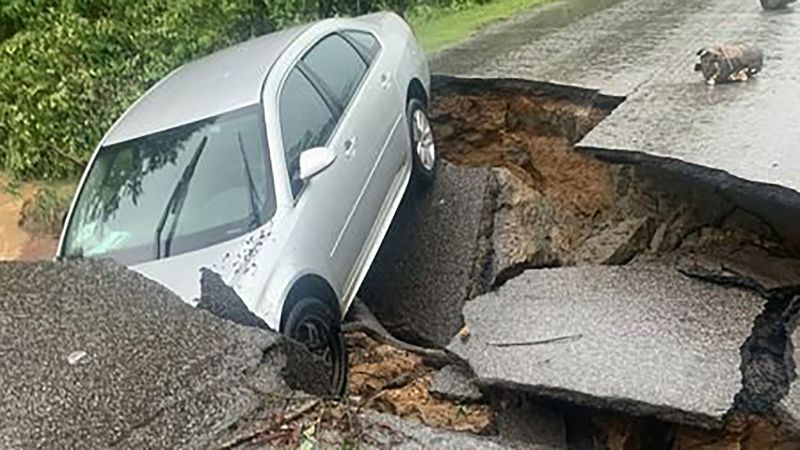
[448,265,764,427]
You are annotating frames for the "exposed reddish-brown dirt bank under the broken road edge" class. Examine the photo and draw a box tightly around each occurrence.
[431,80,788,284]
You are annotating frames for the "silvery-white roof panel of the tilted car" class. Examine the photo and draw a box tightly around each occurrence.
[103,24,312,145]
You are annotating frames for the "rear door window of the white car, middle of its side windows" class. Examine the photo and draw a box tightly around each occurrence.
[303,34,367,109]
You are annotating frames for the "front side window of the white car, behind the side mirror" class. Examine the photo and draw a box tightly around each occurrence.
[278,68,337,196]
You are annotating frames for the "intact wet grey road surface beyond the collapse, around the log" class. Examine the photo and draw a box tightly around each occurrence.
[433,0,800,206]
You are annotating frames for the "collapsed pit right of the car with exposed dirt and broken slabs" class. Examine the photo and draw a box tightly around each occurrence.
[362,72,800,448]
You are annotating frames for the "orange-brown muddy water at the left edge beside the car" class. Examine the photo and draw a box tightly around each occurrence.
[0,180,58,261]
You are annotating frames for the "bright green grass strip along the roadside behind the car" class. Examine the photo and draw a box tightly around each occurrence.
[408,0,549,53]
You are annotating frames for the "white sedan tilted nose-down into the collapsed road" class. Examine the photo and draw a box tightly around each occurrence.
[58,13,437,392]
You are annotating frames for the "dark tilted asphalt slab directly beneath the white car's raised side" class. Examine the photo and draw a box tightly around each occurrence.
[360,163,491,347]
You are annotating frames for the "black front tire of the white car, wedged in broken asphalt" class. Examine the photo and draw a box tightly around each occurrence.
[284,295,347,396]
